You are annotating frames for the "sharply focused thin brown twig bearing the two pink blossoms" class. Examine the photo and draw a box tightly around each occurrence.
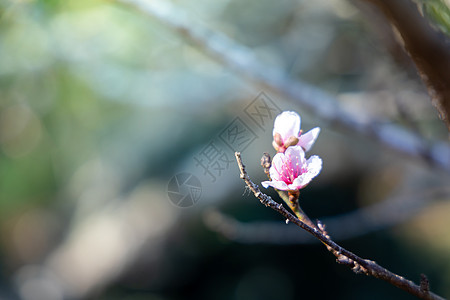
[235,152,444,299]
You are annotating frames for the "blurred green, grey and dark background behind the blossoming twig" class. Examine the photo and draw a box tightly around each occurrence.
[0,0,450,300]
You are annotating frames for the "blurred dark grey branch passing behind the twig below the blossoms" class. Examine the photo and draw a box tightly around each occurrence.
[204,186,450,244]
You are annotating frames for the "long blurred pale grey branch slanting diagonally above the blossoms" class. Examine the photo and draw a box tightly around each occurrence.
[116,0,450,172]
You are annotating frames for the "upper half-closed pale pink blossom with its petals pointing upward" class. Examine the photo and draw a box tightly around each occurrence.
[273,111,320,152]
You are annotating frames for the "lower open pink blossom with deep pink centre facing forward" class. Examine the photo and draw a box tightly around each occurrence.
[261,146,322,191]
